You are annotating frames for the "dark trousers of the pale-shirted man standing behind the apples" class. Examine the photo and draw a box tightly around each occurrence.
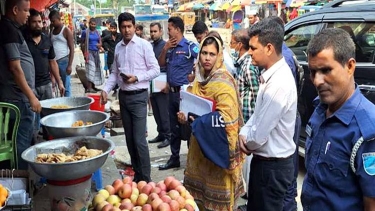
[119,90,151,182]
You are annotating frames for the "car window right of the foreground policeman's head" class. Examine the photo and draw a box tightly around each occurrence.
[327,22,375,62]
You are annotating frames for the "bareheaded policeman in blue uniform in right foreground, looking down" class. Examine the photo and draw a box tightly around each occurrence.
[301,28,375,211]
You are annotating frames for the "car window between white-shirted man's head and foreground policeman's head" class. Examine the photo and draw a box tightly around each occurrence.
[284,23,321,61]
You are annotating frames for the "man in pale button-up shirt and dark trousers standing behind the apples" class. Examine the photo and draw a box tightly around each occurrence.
[101,12,160,182]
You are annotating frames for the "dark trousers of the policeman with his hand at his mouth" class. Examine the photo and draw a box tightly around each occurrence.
[169,92,181,161]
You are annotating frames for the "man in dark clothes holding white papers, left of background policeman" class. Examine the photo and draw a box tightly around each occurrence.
[148,22,171,148]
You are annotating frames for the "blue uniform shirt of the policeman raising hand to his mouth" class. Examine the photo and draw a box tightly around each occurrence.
[167,37,199,87]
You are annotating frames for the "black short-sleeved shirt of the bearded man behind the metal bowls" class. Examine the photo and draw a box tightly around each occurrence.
[24,31,56,87]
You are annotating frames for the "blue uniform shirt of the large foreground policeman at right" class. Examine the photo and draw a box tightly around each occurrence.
[301,87,375,211]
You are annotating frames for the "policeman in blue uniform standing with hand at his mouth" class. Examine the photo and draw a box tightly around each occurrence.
[158,17,199,170]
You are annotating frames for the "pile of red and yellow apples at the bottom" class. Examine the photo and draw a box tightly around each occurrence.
[91,176,197,211]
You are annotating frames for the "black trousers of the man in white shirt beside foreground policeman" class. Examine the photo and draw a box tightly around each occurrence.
[247,156,294,211]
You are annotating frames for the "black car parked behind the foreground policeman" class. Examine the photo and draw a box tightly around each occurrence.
[284,0,375,156]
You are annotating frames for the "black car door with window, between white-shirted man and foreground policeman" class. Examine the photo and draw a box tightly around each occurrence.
[284,14,326,152]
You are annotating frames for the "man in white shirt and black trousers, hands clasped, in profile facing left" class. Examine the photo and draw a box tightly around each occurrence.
[239,18,297,211]
